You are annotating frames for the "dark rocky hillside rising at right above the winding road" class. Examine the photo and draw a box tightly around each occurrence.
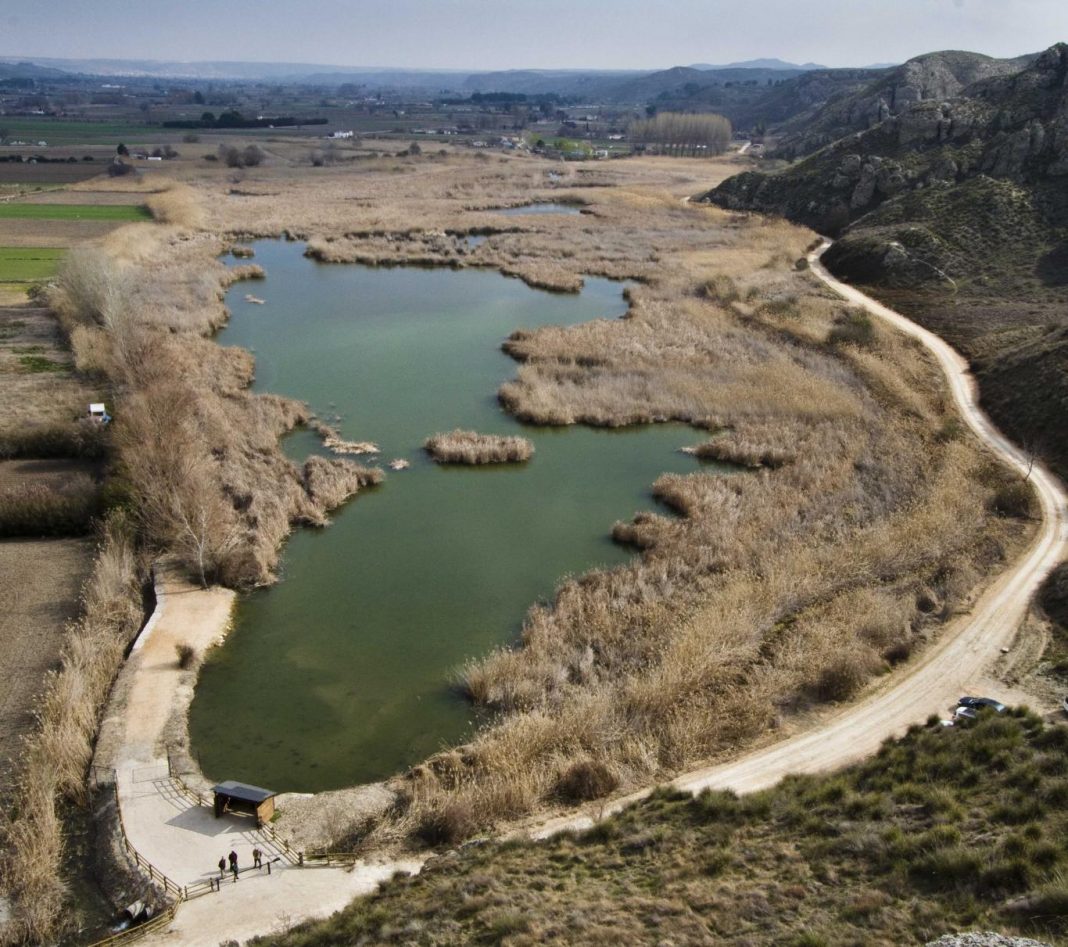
[702,44,1068,475]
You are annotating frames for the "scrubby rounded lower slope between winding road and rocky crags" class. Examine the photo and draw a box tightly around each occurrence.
[827,177,1068,476]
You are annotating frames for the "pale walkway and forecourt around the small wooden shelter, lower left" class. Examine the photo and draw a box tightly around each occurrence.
[115,577,422,947]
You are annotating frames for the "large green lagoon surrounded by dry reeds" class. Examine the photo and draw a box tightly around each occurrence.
[190,241,698,791]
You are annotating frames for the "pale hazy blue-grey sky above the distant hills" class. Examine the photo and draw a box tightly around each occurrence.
[0,0,1068,69]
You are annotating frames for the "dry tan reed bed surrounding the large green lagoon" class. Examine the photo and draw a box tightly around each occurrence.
[35,157,1027,858]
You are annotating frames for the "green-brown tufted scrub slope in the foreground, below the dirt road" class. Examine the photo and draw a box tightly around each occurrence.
[254,712,1068,947]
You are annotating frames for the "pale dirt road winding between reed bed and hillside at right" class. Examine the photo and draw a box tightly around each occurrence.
[532,241,1068,838]
